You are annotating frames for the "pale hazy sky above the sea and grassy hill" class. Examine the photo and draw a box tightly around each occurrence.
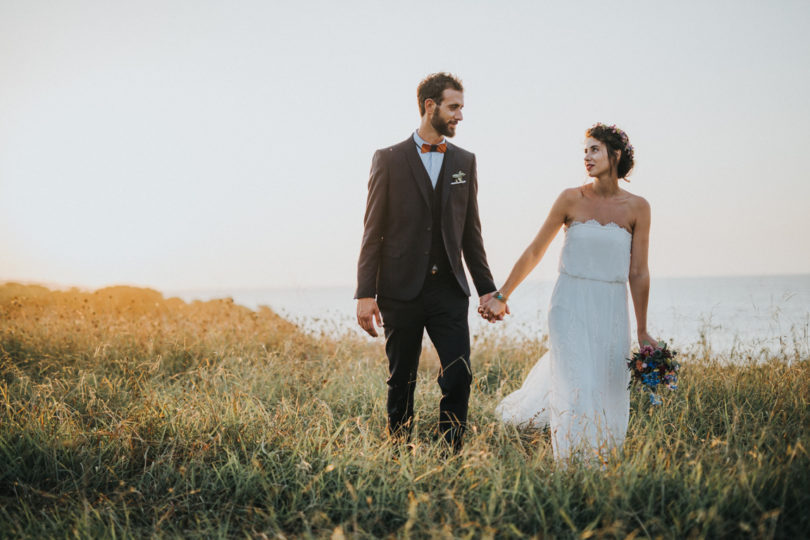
[0,0,810,296]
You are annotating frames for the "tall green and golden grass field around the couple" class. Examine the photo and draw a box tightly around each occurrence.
[0,284,810,538]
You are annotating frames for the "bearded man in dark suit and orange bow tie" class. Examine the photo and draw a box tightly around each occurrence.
[355,73,504,450]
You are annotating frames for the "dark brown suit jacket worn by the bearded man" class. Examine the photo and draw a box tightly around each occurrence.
[355,136,496,300]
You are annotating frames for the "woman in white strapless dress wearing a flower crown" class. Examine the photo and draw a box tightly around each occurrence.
[479,124,656,461]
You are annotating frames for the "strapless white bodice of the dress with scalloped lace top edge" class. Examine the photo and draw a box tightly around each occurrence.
[559,219,633,283]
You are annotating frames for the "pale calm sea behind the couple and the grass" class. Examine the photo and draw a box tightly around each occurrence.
[164,274,810,359]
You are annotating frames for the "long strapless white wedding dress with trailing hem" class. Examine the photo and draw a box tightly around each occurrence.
[495,220,632,460]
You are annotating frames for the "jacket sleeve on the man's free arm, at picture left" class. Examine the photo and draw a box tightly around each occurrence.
[354,150,388,298]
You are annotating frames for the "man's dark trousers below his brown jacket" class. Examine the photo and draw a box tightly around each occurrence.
[378,273,472,450]
